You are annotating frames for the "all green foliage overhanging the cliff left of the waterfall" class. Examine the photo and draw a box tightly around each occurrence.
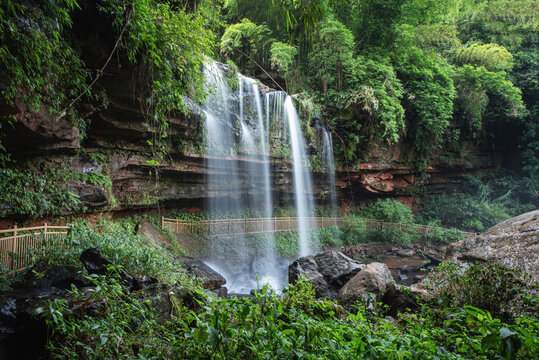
[0,0,220,151]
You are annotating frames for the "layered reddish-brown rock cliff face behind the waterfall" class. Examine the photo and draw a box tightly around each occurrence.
[3,91,494,215]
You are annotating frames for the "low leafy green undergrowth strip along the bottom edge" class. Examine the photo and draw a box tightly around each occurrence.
[36,277,539,360]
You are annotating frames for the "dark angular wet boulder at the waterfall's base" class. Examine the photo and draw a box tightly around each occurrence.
[288,250,365,299]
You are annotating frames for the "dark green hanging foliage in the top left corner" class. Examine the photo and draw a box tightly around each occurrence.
[0,0,89,113]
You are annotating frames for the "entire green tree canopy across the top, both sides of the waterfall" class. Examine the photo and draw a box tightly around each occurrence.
[0,0,539,171]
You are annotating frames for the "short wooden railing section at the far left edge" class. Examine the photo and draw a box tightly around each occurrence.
[0,223,71,271]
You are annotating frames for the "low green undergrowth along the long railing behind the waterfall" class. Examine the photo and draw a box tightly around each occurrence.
[166,199,465,257]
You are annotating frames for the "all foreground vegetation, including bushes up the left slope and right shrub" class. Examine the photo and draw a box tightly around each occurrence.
[4,223,539,360]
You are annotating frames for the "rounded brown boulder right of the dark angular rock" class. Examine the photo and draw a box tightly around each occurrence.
[337,262,393,306]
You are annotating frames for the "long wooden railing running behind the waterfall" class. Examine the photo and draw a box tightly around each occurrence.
[161,217,472,236]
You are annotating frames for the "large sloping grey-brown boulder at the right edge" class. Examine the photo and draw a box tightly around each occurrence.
[445,210,539,281]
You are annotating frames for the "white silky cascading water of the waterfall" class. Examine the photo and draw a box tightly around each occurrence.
[202,63,316,293]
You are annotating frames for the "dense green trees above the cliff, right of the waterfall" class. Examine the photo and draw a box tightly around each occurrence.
[217,0,538,172]
